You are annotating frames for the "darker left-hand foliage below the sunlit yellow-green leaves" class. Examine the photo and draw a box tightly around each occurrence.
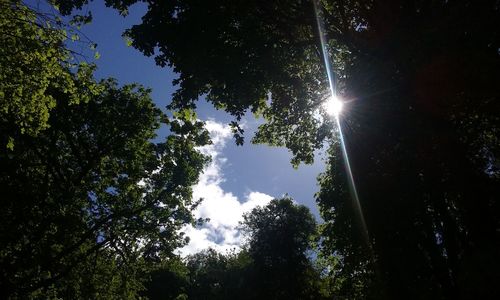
[0,72,208,299]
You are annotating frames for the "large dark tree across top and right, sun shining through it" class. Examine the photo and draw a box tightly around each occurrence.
[54,0,500,299]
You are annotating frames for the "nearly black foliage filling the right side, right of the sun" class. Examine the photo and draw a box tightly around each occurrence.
[317,1,500,299]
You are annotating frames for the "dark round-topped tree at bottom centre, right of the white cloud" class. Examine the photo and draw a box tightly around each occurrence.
[242,198,322,299]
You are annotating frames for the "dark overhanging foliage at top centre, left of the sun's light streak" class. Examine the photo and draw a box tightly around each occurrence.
[52,0,338,165]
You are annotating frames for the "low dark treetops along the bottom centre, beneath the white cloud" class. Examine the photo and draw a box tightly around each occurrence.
[146,198,328,300]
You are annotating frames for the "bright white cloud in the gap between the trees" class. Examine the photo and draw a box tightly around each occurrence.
[179,120,273,256]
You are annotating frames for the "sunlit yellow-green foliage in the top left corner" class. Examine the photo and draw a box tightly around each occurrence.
[0,0,99,149]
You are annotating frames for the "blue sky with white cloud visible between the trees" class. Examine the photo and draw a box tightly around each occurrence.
[68,0,324,255]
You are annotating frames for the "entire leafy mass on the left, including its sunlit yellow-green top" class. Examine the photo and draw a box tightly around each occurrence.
[0,1,209,299]
